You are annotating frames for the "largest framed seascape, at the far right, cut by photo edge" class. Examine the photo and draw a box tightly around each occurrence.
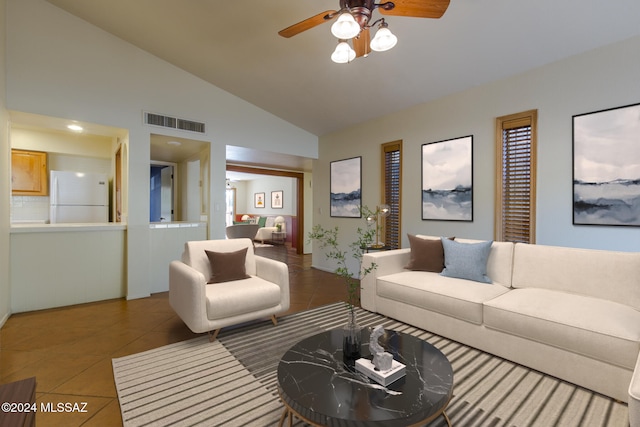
[573,104,640,227]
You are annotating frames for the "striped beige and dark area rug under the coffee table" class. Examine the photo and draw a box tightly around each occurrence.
[113,304,629,427]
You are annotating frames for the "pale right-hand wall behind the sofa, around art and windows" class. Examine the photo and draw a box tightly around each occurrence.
[313,37,640,274]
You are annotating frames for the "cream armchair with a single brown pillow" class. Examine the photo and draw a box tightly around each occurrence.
[169,239,289,341]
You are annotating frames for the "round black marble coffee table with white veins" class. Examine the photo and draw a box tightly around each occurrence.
[278,329,453,427]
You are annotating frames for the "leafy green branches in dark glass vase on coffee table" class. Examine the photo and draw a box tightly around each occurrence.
[309,206,378,363]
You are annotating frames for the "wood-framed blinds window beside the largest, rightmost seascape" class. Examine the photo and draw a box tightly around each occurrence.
[495,110,537,243]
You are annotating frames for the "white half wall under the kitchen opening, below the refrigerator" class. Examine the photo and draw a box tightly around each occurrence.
[10,223,128,313]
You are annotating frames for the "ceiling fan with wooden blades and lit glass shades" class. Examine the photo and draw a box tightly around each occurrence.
[278,0,450,63]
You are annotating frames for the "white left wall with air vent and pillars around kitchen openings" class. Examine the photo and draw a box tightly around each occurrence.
[0,0,318,304]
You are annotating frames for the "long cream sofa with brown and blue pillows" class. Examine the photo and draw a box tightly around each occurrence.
[361,236,640,426]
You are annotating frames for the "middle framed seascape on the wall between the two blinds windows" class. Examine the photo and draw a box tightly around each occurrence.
[421,135,473,221]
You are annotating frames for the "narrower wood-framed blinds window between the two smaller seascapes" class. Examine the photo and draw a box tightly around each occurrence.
[382,141,402,249]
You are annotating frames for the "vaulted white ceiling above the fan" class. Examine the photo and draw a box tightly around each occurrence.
[48,0,640,139]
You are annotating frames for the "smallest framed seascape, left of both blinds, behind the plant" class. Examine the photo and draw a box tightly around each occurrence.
[329,157,362,218]
